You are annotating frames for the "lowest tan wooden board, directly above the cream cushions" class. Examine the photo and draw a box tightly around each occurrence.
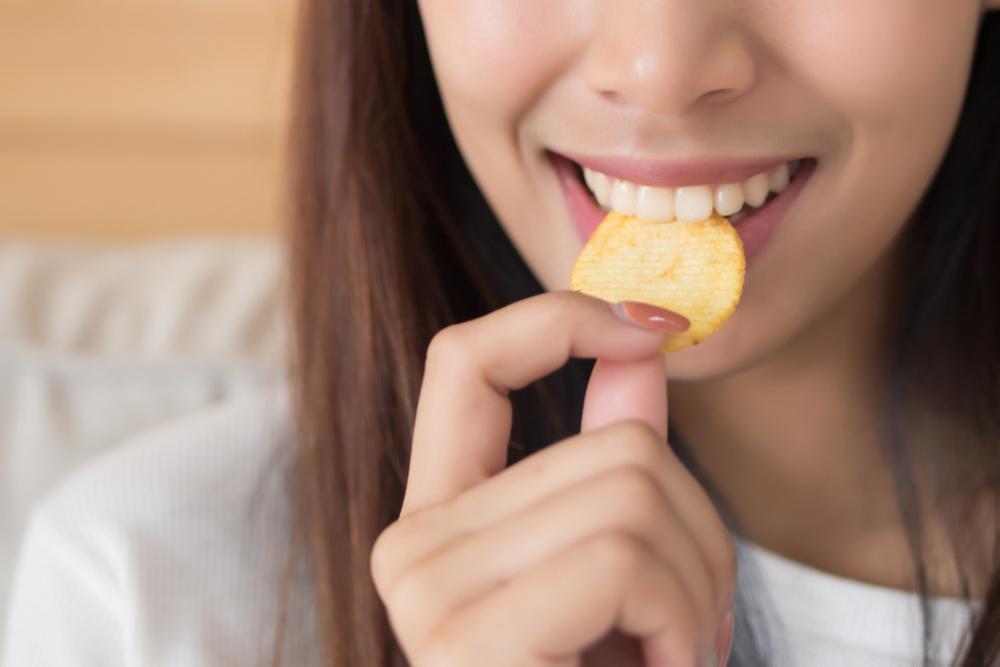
[0,151,281,238]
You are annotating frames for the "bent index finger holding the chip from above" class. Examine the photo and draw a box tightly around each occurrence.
[401,290,687,516]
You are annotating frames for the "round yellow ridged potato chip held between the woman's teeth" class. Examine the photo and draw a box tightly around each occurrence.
[570,211,746,352]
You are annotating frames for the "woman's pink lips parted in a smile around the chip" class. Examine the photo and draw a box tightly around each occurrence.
[549,152,816,268]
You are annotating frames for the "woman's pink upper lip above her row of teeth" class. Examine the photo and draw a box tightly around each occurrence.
[552,151,804,187]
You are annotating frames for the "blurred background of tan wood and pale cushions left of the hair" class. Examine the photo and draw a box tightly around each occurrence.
[0,0,295,648]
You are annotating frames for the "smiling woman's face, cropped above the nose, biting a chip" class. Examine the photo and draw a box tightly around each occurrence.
[419,0,1000,379]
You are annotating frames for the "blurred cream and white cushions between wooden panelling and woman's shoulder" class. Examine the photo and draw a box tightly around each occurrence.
[0,237,284,651]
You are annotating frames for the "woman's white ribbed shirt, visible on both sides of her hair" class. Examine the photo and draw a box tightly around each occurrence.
[3,389,969,667]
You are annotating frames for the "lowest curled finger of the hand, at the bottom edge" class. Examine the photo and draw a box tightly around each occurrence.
[417,532,712,667]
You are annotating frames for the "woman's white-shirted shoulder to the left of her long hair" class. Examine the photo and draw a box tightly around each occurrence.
[4,386,322,665]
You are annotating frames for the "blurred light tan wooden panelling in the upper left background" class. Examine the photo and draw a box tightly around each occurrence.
[0,0,295,237]
